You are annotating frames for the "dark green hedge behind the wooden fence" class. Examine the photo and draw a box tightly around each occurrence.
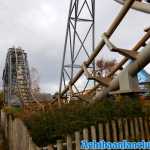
[21,97,144,146]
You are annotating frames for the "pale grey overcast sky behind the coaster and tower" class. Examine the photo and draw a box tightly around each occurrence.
[0,0,150,93]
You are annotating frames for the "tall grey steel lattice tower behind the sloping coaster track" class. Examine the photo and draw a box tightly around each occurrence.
[59,0,95,99]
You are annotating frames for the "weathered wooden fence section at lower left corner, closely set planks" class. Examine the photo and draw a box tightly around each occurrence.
[1,111,40,150]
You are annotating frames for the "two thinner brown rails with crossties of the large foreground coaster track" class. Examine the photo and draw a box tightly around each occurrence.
[55,0,150,104]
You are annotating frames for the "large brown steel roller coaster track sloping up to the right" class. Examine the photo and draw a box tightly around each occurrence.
[57,0,150,106]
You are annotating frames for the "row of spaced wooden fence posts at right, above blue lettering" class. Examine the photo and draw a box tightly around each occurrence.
[41,117,150,150]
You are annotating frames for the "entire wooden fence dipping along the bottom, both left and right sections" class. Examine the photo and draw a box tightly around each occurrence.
[1,112,150,150]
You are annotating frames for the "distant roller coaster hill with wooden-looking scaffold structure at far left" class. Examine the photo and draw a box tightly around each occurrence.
[3,48,31,105]
